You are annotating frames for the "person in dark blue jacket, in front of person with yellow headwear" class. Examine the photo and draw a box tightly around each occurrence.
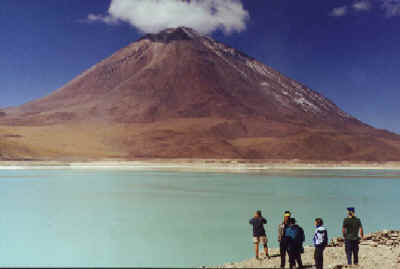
[285,218,305,269]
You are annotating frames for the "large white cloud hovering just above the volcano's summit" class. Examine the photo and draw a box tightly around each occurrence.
[87,0,249,34]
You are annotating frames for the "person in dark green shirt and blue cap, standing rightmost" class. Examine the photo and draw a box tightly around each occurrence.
[342,207,364,265]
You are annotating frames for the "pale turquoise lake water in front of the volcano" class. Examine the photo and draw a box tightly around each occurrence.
[0,170,400,267]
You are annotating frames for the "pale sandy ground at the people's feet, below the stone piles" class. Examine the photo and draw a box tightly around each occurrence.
[215,245,400,269]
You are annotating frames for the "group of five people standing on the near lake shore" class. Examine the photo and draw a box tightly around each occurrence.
[249,207,364,269]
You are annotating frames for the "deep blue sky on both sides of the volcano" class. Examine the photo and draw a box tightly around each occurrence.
[0,0,400,133]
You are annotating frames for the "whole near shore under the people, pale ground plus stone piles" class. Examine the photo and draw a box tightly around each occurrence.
[215,230,400,269]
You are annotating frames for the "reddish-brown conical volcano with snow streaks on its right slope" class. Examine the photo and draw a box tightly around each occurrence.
[0,27,400,161]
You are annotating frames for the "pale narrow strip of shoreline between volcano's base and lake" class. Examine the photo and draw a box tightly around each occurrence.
[0,159,400,172]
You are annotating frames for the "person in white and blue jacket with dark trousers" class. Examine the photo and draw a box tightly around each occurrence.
[313,218,328,269]
